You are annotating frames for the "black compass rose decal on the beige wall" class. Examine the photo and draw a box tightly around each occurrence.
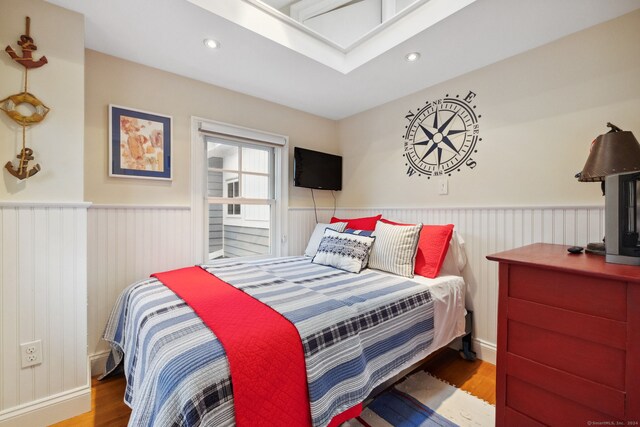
[402,91,482,179]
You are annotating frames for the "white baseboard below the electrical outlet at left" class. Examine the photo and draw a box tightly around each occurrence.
[0,383,91,427]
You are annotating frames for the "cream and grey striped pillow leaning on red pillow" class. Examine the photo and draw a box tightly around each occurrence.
[369,221,422,277]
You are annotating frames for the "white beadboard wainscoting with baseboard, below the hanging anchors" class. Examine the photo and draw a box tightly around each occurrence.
[0,202,91,426]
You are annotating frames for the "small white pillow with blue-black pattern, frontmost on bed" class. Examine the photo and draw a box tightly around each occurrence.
[311,229,375,273]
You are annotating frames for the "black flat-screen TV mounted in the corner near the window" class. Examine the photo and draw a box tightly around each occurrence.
[293,147,342,191]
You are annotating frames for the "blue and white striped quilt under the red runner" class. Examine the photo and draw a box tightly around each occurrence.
[104,257,434,426]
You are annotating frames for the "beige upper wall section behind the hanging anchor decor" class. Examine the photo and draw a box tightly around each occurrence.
[0,0,84,202]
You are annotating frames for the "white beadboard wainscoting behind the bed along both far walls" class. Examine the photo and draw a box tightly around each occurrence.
[87,205,604,375]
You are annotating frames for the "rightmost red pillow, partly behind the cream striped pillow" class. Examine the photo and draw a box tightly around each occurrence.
[381,219,453,279]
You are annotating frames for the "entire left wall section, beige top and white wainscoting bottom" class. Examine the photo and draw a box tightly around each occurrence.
[0,0,91,427]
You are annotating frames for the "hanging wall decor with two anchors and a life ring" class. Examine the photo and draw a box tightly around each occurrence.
[0,16,49,180]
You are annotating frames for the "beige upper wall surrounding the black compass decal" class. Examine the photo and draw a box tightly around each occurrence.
[339,11,640,207]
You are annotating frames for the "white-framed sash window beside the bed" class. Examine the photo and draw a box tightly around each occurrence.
[191,117,289,262]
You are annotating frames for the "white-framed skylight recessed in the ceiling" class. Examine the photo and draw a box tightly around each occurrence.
[189,0,475,74]
